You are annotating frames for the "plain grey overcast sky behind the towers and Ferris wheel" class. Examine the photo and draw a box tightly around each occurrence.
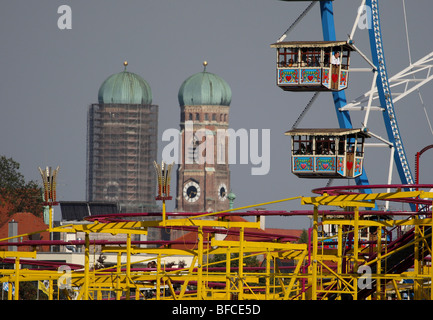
[0,0,433,229]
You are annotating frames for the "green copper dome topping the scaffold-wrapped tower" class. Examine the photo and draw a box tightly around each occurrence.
[98,62,152,104]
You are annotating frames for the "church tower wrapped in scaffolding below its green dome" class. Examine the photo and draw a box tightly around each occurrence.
[87,61,158,212]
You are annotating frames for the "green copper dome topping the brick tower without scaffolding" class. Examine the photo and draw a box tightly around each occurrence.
[178,63,232,106]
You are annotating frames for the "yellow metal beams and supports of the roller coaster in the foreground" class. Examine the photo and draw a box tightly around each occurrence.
[0,190,433,300]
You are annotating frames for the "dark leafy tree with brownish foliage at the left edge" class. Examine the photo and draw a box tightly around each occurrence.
[0,156,43,217]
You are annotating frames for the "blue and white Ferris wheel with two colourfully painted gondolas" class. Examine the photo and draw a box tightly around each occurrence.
[271,0,433,193]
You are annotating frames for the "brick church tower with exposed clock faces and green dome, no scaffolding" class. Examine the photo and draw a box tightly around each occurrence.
[176,62,232,212]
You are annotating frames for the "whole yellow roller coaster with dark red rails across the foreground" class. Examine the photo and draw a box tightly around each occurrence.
[0,185,433,300]
